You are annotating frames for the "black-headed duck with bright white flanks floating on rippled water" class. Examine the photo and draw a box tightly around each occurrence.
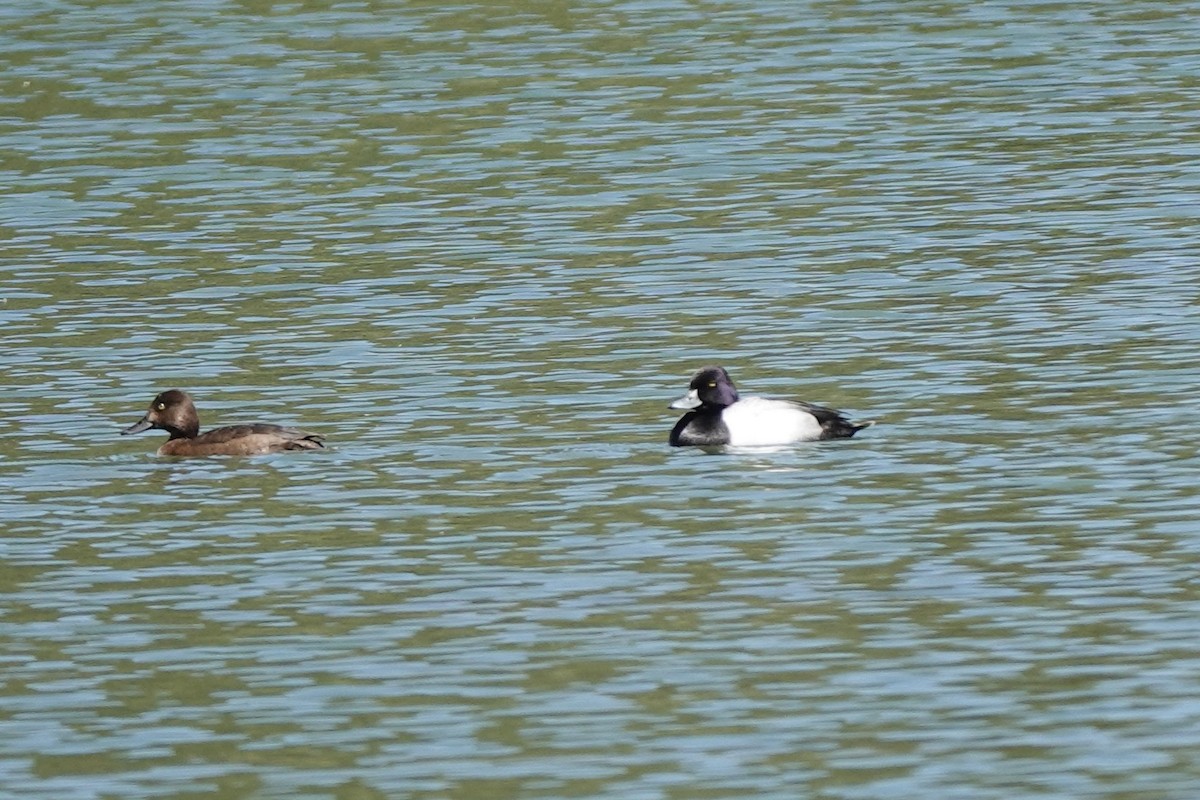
[670,366,875,447]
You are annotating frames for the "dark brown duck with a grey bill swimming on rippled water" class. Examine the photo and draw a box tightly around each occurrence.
[121,389,325,456]
